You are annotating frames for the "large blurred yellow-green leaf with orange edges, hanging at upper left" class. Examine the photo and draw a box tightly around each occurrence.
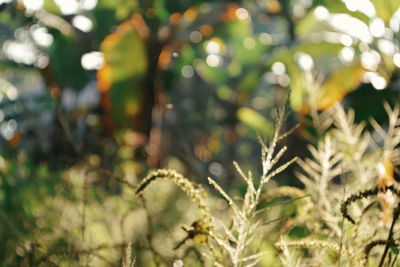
[98,15,148,128]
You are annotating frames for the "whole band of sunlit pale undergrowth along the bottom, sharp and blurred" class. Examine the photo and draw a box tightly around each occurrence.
[5,103,400,267]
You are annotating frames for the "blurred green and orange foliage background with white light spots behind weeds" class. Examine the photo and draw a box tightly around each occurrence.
[0,0,400,266]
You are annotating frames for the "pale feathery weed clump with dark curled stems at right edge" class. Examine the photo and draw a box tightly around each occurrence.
[276,103,400,266]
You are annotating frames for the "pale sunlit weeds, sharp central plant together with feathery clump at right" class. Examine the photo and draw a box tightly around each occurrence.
[136,103,400,267]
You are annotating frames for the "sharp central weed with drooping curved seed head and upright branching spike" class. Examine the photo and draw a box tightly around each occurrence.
[136,103,297,267]
